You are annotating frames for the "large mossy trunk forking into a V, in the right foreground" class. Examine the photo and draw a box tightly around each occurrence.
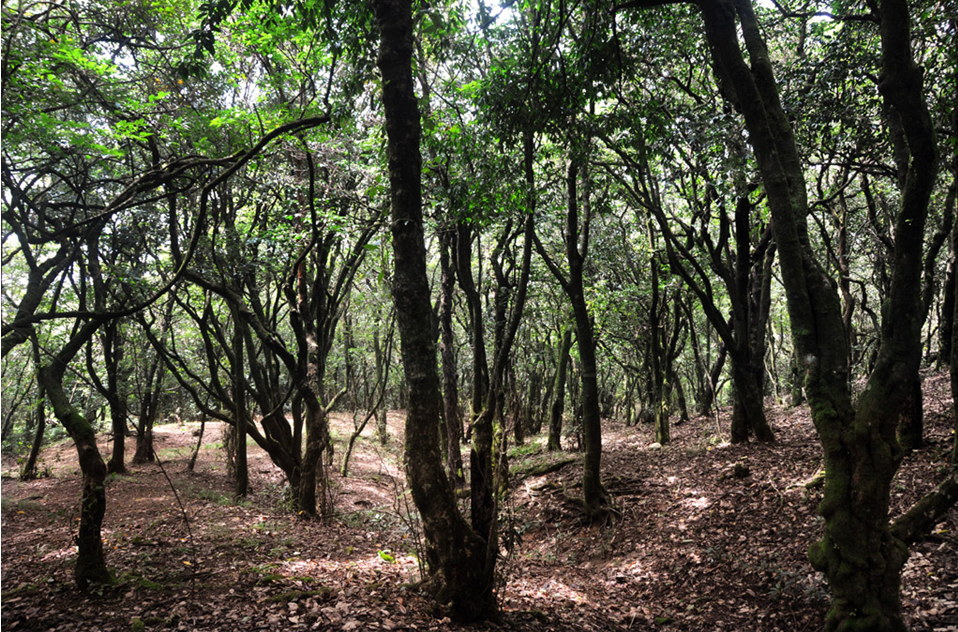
[699,0,937,632]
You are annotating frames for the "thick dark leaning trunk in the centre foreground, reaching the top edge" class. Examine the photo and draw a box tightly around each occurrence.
[373,0,496,620]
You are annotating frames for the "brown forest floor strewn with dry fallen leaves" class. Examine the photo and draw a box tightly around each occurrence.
[0,375,958,632]
